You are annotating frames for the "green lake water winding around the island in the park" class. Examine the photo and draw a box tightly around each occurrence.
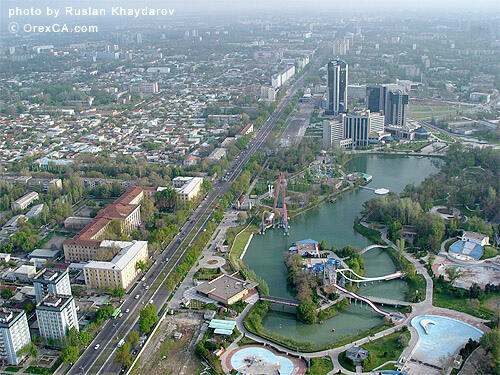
[244,155,439,345]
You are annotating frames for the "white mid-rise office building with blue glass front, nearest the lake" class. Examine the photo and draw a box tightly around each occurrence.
[342,110,385,146]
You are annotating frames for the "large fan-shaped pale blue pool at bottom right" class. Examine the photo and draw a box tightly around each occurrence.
[411,315,483,367]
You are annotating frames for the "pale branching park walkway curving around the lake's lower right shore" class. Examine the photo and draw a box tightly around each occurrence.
[231,222,489,375]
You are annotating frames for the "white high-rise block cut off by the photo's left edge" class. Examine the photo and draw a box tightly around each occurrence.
[0,308,31,366]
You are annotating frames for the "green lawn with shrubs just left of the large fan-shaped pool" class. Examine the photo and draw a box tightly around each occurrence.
[363,331,410,371]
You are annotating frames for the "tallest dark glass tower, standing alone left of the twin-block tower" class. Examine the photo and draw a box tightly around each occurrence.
[327,60,348,115]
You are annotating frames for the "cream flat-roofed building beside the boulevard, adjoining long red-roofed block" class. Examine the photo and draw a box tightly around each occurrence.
[83,241,148,289]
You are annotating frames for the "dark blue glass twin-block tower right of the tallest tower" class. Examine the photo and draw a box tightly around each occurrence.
[366,84,408,126]
